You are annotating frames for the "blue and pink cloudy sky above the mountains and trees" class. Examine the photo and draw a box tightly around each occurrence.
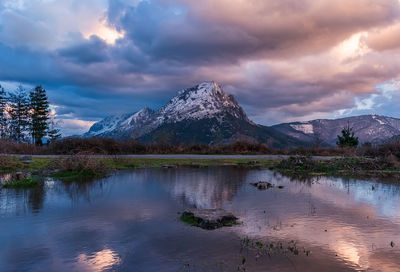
[0,0,400,135]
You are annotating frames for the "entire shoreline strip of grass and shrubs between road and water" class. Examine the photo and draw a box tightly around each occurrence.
[0,154,400,181]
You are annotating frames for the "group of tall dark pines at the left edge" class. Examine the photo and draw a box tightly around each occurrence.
[0,85,61,146]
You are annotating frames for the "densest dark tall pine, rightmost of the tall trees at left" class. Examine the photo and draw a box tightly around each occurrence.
[29,86,50,145]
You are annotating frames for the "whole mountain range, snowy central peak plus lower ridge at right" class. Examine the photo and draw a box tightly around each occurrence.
[83,81,400,148]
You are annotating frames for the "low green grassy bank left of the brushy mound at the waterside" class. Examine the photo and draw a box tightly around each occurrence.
[0,156,275,181]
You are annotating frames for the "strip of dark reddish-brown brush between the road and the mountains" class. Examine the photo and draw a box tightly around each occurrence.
[0,138,400,160]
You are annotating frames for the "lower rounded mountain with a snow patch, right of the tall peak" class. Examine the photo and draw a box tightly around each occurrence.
[272,115,400,146]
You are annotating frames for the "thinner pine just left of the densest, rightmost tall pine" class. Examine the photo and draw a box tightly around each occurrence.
[8,86,30,142]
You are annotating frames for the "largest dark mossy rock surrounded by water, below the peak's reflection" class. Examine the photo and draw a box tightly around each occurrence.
[180,209,238,230]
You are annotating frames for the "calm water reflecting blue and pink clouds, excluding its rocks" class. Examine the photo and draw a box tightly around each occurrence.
[0,167,400,271]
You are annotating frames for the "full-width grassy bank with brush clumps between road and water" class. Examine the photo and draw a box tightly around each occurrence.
[0,156,400,182]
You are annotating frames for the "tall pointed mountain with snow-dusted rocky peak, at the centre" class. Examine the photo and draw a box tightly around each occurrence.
[83,81,302,148]
